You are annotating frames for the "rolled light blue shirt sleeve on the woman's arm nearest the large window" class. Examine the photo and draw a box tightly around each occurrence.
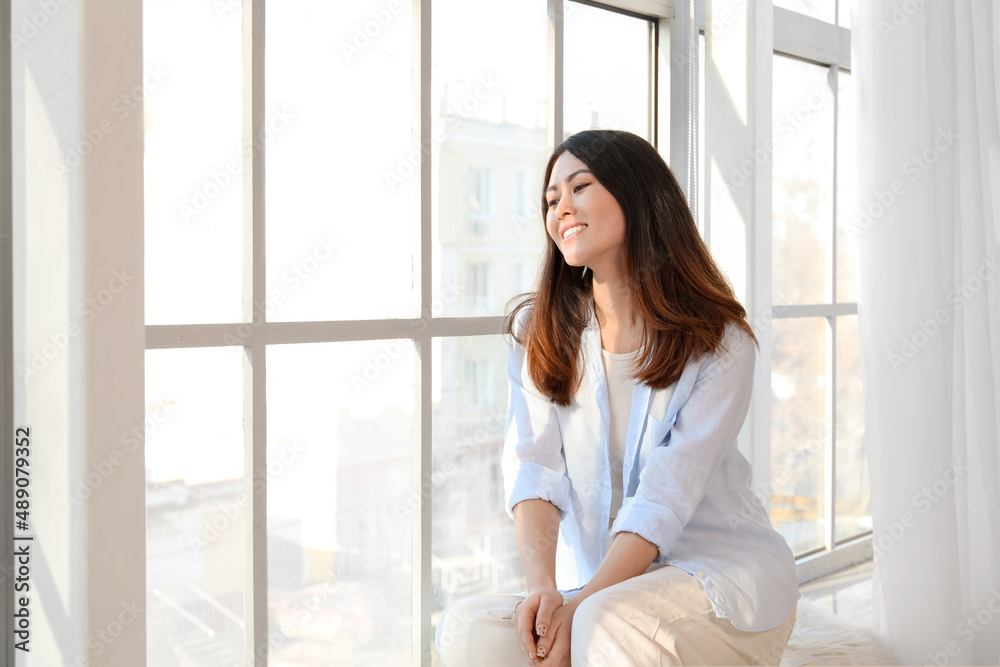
[501,311,570,521]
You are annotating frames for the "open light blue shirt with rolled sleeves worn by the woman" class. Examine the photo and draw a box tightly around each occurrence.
[501,307,801,632]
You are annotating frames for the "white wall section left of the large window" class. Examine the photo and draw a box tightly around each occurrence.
[11,0,145,667]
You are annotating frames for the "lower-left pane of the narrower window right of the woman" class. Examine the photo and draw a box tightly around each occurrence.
[771,317,829,555]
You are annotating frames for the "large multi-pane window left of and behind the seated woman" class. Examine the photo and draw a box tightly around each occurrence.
[144,0,665,667]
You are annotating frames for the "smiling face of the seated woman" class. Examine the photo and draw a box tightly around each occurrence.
[545,152,625,280]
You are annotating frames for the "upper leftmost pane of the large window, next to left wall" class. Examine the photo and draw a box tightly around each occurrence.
[144,0,243,324]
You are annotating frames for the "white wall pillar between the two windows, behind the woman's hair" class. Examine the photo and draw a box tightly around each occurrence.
[704,0,773,498]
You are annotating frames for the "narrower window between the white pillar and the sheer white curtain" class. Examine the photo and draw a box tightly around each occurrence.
[771,9,872,556]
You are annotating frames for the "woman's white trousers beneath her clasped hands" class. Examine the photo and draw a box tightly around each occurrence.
[435,564,798,667]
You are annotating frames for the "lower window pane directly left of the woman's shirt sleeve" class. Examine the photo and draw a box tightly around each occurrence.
[431,336,526,660]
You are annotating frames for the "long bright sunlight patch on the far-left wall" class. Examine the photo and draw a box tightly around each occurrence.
[21,61,76,664]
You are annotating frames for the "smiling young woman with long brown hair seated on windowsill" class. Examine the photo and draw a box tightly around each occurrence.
[436,130,800,667]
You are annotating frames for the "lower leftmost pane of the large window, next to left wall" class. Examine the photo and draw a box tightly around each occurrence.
[146,347,244,667]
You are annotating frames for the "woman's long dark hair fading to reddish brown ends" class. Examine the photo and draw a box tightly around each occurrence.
[504,130,760,406]
